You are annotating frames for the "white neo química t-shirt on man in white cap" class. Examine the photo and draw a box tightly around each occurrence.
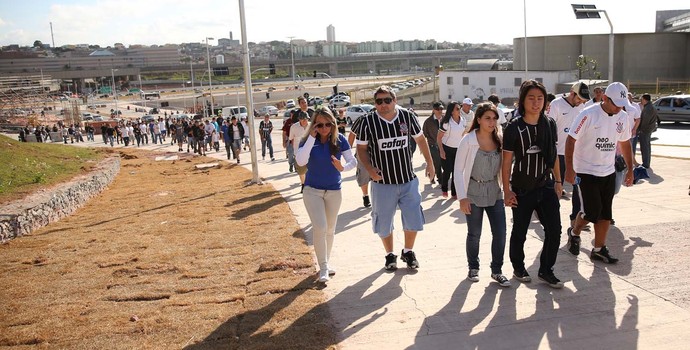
[568,104,632,176]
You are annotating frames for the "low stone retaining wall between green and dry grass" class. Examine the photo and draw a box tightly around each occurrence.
[0,157,120,243]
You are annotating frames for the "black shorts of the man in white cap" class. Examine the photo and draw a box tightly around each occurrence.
[577,172,616,223]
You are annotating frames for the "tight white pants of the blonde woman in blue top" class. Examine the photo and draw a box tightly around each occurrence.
[302,186,343,270]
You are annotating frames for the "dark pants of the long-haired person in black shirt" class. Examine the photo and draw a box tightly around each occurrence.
[509,181,561,274]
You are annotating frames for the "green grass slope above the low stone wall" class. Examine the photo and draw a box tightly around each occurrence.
[0,135,103,203]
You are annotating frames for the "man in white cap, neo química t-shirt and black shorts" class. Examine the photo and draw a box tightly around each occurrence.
[565,82,633,264]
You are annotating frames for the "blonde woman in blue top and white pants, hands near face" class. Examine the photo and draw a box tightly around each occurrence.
[295,108,357,282]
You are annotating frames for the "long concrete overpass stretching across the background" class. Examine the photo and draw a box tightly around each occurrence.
[0,49,513,92]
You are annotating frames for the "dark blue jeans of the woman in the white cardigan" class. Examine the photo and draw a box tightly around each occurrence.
[465,199,506,274]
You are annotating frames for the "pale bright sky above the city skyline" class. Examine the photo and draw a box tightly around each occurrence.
[0,0,690,47]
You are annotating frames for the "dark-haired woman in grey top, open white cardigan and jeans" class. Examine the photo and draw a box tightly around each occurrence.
[454,103,510,287]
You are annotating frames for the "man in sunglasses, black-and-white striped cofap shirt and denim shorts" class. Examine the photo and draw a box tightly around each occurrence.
[352,85,435,270]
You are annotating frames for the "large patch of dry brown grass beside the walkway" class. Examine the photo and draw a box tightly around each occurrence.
[0,150,335,349]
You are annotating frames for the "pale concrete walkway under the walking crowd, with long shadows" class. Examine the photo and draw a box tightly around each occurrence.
[6,122,690,349]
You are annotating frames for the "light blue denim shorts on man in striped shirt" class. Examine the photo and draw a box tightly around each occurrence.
[371,178,424,238]
